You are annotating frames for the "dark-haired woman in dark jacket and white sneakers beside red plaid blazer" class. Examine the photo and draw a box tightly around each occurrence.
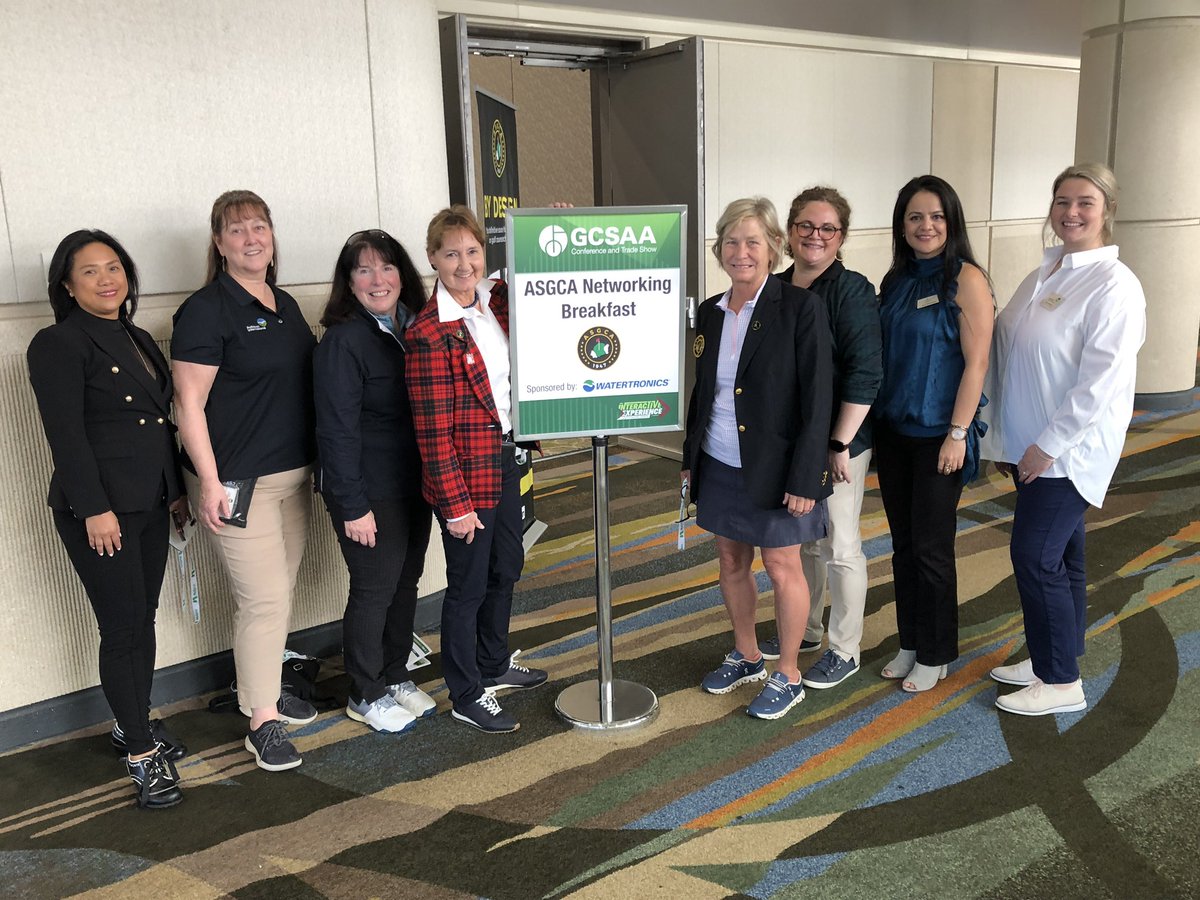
[313,230,437,732]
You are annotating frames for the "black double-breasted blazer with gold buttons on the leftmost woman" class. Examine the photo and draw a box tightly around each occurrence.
[26,307,182,520]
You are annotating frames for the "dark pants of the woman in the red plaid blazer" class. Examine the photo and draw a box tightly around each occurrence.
[438,444,524,707]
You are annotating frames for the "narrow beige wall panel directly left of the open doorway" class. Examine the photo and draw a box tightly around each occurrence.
[364,0,450,256]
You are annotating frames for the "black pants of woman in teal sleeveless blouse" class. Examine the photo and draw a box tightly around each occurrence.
[875,424,962,666]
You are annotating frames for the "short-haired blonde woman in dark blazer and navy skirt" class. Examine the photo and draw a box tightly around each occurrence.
[683,197,833,719]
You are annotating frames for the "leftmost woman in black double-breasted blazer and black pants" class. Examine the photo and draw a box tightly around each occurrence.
[28,230,188,808]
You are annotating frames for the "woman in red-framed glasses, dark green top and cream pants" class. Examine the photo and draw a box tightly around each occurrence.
[761,187,882,690]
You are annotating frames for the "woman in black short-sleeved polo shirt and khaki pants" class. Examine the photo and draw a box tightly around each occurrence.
[170,191,317,772]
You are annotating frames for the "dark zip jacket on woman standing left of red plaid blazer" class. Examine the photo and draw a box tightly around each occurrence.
[312,308,421,521]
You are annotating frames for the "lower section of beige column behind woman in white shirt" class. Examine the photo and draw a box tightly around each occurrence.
[1114,222,1200,394]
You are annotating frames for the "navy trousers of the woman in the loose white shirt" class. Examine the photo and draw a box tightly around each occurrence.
[1009,478,1087,684]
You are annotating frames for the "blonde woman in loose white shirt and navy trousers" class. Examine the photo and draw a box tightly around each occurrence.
[983,163,1146,715]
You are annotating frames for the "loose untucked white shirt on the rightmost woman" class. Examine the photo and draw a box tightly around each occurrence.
[982,246,1146,506]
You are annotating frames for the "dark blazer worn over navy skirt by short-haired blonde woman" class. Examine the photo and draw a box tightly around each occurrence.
[683,277,834,509]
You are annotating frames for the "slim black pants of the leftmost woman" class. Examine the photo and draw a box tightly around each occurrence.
[54,505,169,756]
